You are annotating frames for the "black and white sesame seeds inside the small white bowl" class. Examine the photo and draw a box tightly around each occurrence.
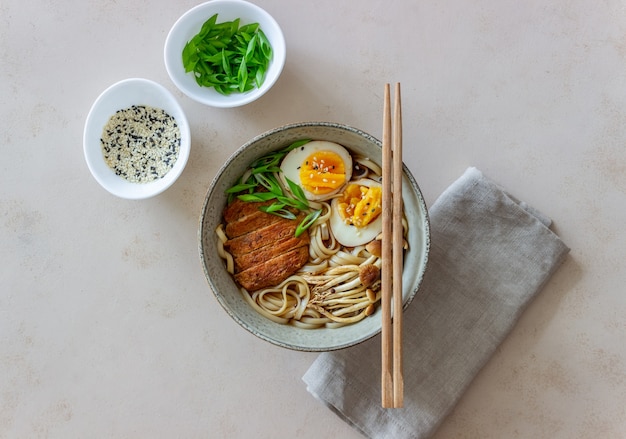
[100,105,180,183]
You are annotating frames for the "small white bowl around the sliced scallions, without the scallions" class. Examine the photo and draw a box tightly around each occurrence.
[164,0,287,108]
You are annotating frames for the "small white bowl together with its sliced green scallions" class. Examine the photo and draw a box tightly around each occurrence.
[164,0,286,108]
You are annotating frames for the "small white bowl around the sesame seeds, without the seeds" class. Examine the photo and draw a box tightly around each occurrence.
[83,78,191,200]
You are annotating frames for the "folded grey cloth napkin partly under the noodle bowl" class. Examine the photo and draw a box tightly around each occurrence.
[303,168,569,439]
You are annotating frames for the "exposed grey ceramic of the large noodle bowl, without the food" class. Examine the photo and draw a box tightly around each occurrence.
[198,123,430,351]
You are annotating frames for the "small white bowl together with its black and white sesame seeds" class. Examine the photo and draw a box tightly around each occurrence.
[83,78,191,200]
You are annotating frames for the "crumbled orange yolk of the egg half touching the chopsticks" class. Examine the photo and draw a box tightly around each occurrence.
[337,184,383,227]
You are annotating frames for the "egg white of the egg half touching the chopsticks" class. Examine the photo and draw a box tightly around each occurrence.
[329,178,383,247]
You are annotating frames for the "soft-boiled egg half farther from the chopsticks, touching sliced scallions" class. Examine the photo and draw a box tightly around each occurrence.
[280,140,352,201]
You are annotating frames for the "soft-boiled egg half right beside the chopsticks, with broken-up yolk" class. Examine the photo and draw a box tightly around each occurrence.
[330,178,383,247]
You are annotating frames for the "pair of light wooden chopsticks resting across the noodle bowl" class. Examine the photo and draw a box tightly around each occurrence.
[381,83,404,408]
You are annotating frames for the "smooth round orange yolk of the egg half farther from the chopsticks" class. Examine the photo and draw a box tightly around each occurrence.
[300,151,346,195]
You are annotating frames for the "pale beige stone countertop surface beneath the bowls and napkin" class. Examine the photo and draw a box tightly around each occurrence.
[0,0,626,439]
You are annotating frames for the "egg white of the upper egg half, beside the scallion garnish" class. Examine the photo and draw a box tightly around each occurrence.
[280,140,352,201]
